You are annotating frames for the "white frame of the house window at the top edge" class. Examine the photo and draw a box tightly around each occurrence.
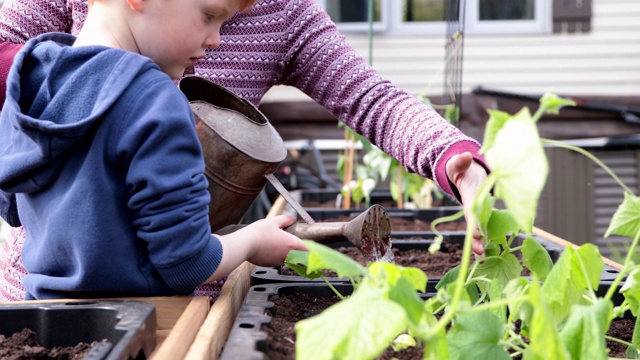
[316,0,553,36]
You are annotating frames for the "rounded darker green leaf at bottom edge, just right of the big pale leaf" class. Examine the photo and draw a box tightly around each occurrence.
[447,311,511,360]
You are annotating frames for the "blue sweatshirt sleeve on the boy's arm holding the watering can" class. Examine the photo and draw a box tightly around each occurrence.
[110,77,222,292]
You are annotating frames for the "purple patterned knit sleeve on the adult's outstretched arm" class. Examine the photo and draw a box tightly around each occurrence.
[281,0,488,200]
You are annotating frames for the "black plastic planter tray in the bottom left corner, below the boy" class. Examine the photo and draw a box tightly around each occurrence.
[0,300,157,360]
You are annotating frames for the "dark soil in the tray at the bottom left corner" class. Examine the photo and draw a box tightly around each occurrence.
[0,329,105,360]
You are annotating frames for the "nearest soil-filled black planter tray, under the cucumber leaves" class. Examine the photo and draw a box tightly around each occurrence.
[220,284,635,360]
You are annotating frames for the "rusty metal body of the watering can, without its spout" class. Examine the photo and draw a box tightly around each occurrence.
[179,77,287,232]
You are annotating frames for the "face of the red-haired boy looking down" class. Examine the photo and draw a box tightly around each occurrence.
[136,0,247,79]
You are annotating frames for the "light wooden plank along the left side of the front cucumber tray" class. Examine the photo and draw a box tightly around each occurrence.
[184,196,286,360]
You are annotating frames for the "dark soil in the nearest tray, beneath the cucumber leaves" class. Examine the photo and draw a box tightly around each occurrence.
[263,293,634,360]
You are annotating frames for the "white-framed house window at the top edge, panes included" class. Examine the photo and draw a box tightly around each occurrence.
[317,0,553,35]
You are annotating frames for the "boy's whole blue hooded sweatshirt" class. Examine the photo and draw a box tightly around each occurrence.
[0,33,222,299]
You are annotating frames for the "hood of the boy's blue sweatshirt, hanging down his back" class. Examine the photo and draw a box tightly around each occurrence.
[0,33,157,193]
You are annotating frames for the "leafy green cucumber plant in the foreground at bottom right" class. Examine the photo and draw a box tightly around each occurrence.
[286,94,640,359]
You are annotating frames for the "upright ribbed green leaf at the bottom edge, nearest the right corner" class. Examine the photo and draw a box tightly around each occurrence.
[560,299,613,360]
